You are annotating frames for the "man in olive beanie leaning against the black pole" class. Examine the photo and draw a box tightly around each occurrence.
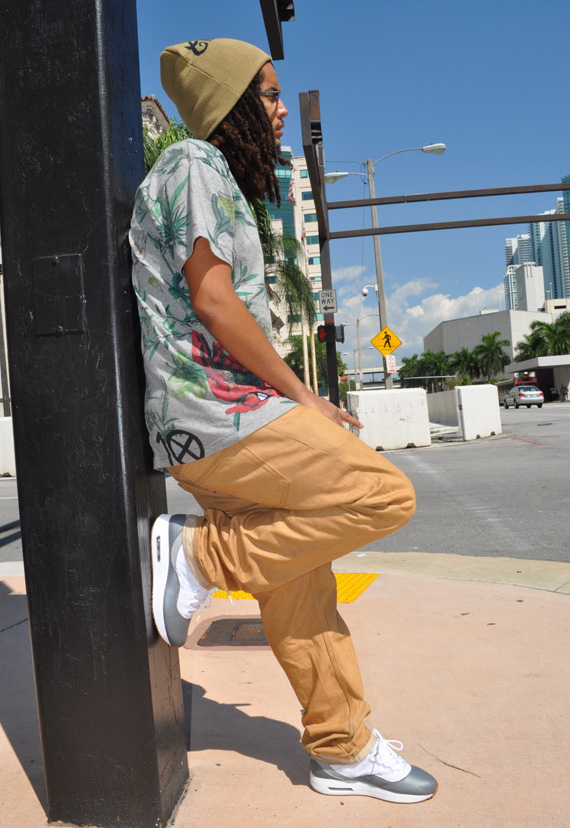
[130,39,437,802]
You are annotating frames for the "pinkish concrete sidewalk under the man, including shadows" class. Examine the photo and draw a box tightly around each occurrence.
[0,553,570,828]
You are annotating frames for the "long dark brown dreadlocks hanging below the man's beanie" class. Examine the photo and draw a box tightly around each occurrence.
[207,72,280,205]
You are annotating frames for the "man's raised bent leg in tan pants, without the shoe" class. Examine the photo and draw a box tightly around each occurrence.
[170,406,415,595]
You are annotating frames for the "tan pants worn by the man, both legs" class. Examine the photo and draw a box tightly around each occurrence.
[169,406,415,764]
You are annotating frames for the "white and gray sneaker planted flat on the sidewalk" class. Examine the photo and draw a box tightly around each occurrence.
[309,730,437,802]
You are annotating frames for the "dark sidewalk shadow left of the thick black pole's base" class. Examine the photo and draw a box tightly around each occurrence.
[0,581,47,811]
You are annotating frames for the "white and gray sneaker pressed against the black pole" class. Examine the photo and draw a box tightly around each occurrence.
[151,515,212,647]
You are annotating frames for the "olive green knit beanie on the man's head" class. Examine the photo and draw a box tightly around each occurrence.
[160,38,271,138]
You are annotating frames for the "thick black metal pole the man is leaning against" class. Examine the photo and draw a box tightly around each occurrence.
[0,0,188,828]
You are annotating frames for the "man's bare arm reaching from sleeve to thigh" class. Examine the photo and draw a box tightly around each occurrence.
[184,238,362,428]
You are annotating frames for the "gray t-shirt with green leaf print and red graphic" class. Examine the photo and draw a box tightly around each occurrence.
[129,139,296,468]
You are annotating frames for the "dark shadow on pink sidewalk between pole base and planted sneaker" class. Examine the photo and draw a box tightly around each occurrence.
[182,680,308,787]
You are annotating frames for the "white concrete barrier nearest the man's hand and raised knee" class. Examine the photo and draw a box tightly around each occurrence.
[347,388,431,451]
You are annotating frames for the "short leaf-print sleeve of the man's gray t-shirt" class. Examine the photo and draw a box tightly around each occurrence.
[164,148,235,272]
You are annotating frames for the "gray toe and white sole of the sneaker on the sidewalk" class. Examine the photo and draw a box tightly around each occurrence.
[309,760,437,804]
